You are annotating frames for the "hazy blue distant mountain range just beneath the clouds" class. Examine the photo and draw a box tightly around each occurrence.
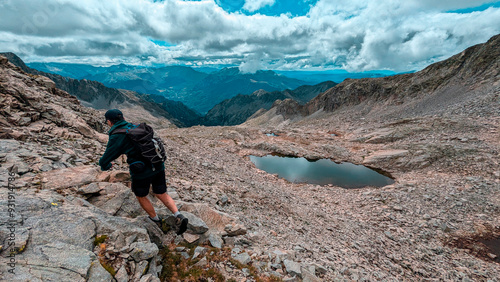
[28,63,307,114]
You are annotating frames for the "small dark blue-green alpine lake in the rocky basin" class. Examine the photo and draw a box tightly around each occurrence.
[249,154,394,189]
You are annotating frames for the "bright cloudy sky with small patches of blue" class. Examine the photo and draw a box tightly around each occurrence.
[0,0,500,72]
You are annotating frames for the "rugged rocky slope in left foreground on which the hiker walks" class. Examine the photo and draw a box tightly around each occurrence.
[0,56,296,282]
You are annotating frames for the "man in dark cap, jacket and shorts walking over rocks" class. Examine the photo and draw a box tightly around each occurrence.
[99,109,188,235]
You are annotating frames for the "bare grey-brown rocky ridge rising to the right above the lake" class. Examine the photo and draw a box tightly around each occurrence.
[247,32,500,123]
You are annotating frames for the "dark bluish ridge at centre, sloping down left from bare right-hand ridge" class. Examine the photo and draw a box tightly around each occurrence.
[201,81,336,126]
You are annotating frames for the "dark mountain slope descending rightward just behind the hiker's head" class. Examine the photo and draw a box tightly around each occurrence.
[0,53,198,127]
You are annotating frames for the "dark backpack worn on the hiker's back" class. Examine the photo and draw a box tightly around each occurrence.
[111,123,167,164]
